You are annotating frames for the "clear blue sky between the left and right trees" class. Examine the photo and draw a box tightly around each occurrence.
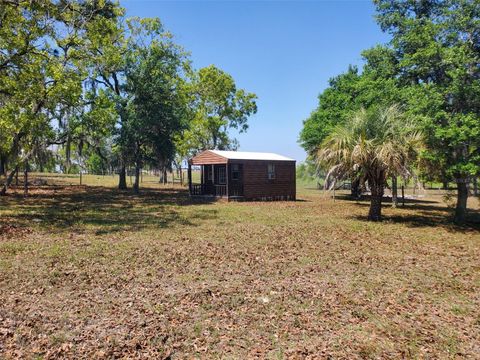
[121,0,388,161]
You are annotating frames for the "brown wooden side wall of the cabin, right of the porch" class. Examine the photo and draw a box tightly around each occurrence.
[242,160,296,200]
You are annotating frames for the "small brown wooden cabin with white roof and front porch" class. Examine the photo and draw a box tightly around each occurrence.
[188,150,296,200]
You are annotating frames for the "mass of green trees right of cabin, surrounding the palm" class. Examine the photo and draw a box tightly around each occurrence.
[300,0,480,223]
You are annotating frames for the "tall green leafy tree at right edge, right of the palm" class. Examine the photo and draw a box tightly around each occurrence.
[375,0,480,224]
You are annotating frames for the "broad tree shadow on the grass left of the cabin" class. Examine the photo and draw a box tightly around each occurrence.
[0,186,217,235]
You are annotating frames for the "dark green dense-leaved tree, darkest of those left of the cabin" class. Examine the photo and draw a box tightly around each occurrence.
[124,20,188,192]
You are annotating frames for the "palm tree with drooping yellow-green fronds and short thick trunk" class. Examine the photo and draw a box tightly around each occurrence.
[317,105,422,221]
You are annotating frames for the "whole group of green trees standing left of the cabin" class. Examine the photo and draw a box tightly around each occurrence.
[0,0,257,194]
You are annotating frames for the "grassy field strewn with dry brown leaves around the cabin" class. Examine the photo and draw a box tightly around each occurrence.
[0,175,480,359]
